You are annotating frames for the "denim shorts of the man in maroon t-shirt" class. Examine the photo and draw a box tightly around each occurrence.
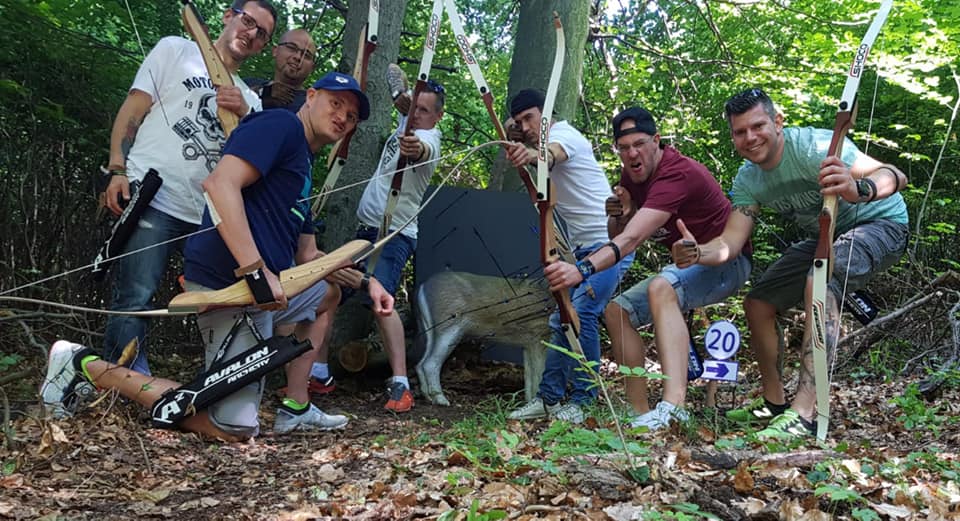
[614,253,752,328]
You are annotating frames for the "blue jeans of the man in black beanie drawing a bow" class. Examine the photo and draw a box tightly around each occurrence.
[537,243,633,405]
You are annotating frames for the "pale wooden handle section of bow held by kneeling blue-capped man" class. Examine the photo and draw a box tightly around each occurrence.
[167,240,374,313]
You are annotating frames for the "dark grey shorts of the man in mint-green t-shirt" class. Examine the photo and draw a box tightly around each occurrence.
[747,221,909,312]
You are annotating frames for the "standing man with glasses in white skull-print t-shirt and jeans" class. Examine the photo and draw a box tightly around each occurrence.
[103,0,277,374]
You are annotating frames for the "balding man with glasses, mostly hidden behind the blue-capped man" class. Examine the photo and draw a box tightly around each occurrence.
[247,29,317,112]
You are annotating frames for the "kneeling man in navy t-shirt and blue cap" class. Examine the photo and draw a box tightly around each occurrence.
[41,73,393,440]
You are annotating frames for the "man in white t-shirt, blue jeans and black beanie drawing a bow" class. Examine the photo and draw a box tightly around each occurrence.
[507,89,633,423]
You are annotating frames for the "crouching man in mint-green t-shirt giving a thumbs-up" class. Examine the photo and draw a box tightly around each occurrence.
[673,89,908,438]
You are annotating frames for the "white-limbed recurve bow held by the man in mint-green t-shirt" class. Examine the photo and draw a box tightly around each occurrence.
[807,0,893,441]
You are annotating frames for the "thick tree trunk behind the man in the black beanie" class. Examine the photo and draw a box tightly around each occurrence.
[490,0,590,191]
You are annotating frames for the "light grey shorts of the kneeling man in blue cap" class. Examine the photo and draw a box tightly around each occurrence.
[186,281,328,436]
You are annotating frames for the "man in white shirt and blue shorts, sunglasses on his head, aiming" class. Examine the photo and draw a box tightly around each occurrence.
[342,74,446,413]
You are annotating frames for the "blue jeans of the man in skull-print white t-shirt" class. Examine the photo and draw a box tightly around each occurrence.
[103,204,196,375]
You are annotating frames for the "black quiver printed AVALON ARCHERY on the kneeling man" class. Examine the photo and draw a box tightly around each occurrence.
[150,335,311,429]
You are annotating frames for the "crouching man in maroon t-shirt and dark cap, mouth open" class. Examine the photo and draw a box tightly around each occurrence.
[544,107,751,431]
